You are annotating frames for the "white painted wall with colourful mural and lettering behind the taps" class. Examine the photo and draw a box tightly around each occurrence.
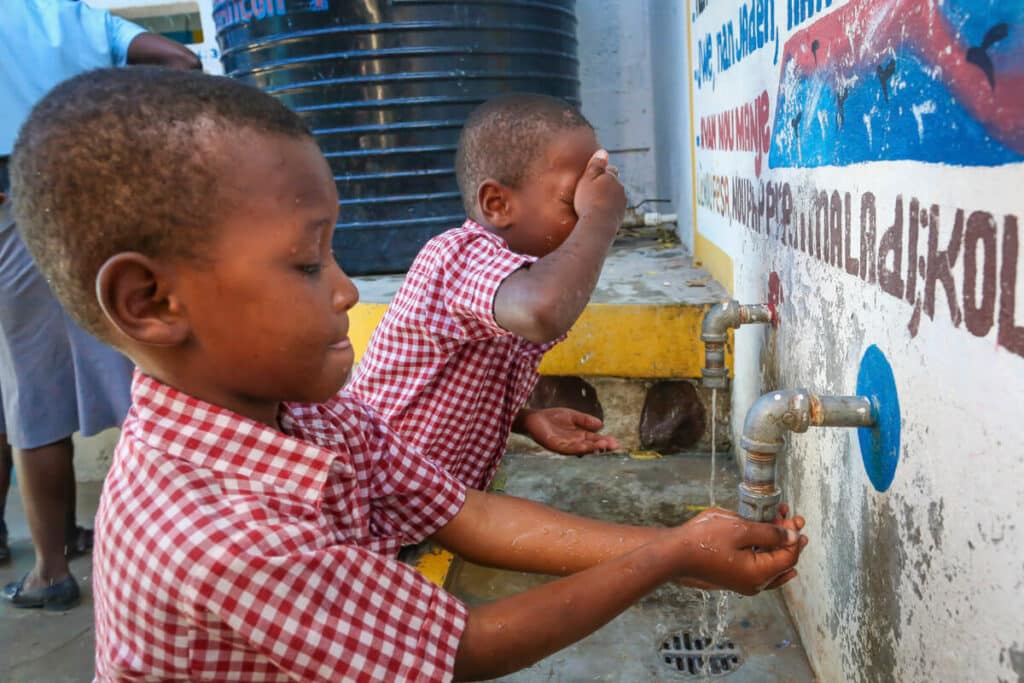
[687,0,1024,683]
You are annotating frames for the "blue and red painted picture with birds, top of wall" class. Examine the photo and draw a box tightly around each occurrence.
[770,0,1024,167]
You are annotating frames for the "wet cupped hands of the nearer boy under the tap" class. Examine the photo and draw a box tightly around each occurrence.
[678,504,807,595]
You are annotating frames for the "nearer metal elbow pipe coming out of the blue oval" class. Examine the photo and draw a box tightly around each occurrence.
[739,389,878,521]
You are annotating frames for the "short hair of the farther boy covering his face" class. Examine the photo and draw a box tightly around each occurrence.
[455,92,593,220]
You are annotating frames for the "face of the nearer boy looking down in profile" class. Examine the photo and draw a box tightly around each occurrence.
[169,134,358,417]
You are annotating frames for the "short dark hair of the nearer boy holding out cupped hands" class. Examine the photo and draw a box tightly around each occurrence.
[11,67,311,338]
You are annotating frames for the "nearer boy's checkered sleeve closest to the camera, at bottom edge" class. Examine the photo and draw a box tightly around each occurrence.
[189,538,468,683]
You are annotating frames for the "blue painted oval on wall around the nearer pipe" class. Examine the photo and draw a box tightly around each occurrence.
[857,344,900,492]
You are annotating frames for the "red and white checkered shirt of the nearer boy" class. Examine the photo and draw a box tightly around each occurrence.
[93,374,467,683]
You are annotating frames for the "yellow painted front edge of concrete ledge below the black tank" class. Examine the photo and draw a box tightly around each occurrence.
[348,303,732,379]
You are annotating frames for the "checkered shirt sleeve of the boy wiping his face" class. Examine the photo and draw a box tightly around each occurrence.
[441,236,534,341]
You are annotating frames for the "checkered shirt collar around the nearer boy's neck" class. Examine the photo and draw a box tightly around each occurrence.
[125,371,355,506]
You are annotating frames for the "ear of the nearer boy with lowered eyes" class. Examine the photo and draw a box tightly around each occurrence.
[96,252,188,346]
